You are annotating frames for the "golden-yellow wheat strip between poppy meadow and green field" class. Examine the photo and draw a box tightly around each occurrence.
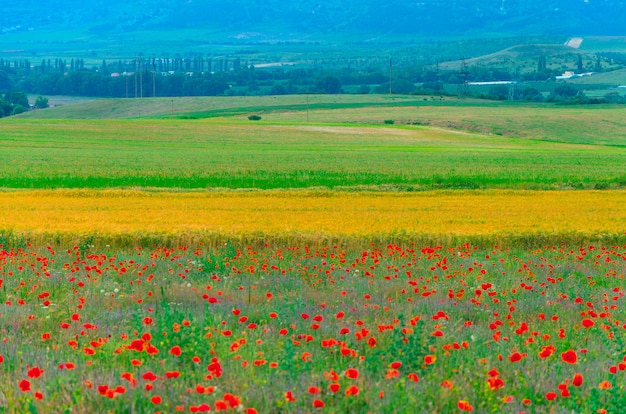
[0,190,626,244]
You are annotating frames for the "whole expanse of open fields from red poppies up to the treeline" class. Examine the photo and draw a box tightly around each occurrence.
[0,95,626,414]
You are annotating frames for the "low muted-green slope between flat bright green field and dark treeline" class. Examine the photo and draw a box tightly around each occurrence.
[17,95,626,146]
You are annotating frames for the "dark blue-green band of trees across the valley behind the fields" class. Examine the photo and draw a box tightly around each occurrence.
[0,56,623,112]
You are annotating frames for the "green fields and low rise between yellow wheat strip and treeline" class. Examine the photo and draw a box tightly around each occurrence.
[0,96,626,190]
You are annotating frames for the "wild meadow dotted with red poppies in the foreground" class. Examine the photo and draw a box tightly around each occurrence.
[0,243,626,413]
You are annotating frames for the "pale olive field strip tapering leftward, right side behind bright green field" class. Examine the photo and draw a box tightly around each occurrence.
[264,102,626,147]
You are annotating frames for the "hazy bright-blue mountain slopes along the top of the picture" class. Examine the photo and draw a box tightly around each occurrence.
[0,0,626,41]
